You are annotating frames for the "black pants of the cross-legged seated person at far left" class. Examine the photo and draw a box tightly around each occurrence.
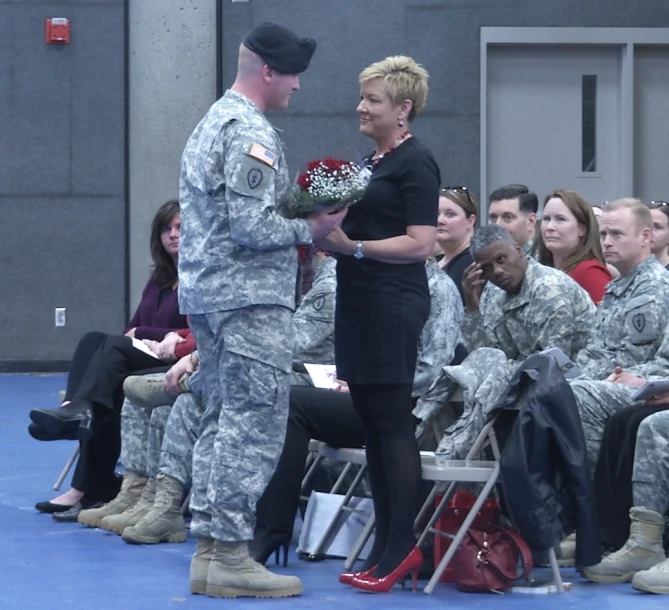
[72,335,166,502]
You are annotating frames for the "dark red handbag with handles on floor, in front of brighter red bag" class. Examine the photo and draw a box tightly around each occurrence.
[453,527,533,593]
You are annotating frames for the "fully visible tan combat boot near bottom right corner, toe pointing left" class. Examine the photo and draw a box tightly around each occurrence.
[581,506,664,583]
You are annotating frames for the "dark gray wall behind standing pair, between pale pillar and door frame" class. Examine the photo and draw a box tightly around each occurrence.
[217,0,669,204]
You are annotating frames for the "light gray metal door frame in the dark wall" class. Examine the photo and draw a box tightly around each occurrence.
[479,27,669,224]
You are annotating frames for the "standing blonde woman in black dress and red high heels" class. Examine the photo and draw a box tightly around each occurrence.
[322,56,440,592]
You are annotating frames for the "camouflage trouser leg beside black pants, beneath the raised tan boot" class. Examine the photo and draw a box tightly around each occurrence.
[121,398,172,477]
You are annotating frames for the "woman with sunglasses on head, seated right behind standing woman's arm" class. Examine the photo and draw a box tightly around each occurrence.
[437,186,479,304]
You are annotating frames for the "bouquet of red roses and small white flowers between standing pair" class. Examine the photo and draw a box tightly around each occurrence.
[283,157,371,218]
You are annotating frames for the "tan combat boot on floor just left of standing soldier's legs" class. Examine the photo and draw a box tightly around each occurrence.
[121,472,186,544]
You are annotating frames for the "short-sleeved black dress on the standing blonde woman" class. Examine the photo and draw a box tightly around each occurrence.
[335,137,440,385]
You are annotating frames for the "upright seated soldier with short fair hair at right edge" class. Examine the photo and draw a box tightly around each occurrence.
[570,199,669,472]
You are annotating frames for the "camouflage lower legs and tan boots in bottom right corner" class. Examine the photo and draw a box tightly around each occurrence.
[582,404,669,594]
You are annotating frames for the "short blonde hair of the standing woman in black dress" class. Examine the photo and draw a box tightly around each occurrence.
[359,55,429,121]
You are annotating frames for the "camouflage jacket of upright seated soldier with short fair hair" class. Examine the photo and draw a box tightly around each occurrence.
[576,256,669,379]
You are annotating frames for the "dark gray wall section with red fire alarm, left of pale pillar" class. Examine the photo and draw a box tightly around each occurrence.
[0,0,126,370]
